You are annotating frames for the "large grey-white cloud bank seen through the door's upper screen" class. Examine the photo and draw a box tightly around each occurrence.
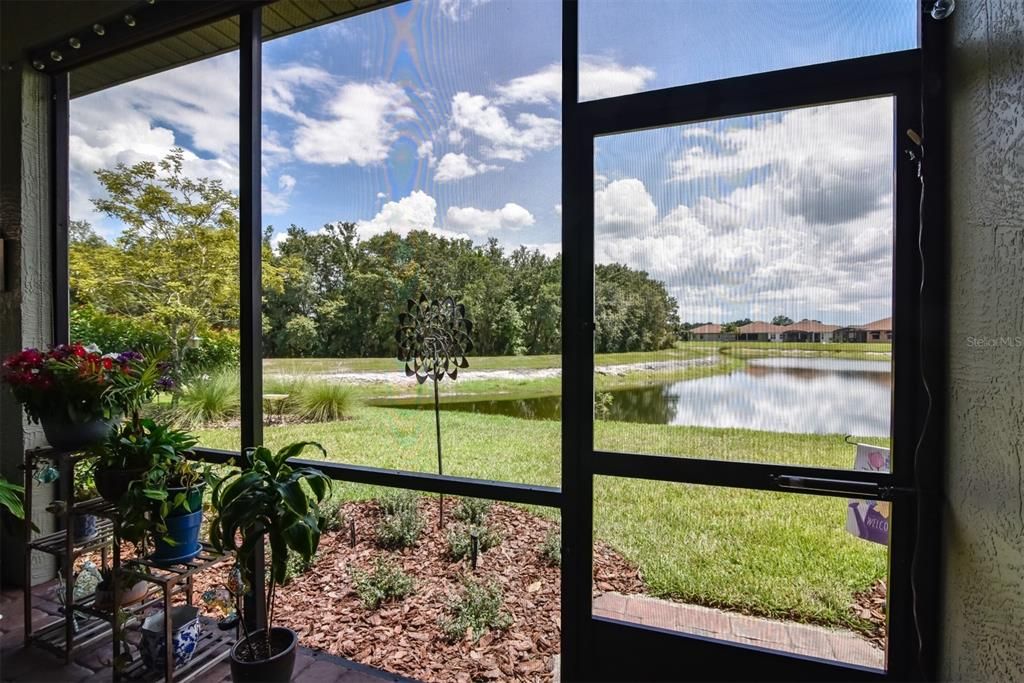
[595,100,893,325]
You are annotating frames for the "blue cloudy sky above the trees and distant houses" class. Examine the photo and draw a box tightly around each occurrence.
[71,0,918,324]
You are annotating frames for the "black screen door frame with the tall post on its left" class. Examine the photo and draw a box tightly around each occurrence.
[562,0,942,681]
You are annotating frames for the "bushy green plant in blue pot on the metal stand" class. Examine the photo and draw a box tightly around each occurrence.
[112,420,206,564]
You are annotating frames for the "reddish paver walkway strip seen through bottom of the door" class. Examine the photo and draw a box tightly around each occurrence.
[594,593,885,669]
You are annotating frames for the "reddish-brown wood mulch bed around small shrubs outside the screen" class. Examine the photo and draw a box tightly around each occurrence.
[188,497,643,681]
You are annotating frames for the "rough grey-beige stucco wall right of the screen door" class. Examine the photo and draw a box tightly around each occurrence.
[940,0,1024,681]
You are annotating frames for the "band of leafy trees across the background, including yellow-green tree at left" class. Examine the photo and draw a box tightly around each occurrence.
[70,150,682,365]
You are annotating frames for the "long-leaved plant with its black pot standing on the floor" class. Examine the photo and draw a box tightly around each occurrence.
[210,441,331,682]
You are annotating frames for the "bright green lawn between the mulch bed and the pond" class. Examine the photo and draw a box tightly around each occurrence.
[200,407,887,628]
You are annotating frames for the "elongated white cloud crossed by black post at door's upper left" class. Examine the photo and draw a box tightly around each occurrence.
[497,55,654,104]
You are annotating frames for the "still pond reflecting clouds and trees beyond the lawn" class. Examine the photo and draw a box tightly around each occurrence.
[378,357,892,436]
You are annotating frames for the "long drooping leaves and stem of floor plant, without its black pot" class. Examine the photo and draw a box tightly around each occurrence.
[210,441,331,658]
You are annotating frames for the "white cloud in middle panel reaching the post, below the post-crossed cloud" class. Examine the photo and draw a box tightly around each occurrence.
[450,92,561,162]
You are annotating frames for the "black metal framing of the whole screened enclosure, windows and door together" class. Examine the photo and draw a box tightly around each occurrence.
[44,0,948,680]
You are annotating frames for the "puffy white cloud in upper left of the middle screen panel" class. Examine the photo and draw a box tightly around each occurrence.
[295,81,416,166]
